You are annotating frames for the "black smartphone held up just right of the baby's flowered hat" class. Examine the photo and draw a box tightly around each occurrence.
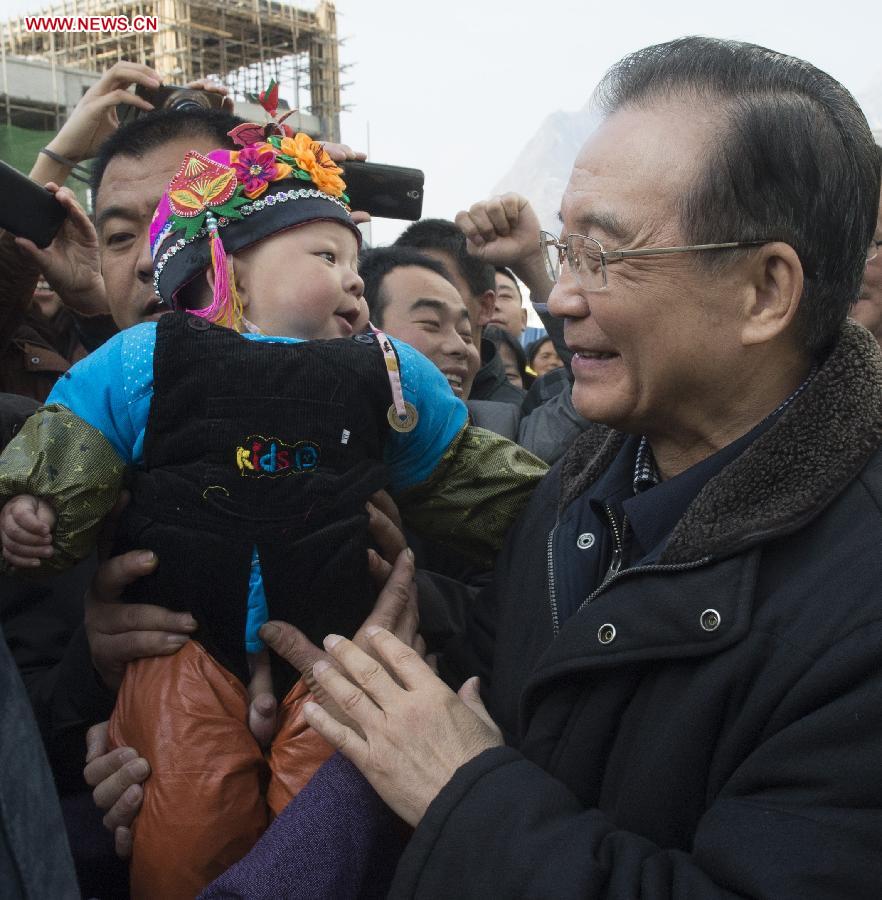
[339,160,426,222]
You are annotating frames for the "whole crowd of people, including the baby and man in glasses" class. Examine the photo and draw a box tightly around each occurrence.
[0,38,882,900]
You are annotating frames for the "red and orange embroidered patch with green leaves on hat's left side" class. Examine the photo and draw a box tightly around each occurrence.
[168,150,248,241]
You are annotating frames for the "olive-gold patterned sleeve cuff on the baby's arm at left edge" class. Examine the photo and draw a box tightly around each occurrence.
[0,404,126,573]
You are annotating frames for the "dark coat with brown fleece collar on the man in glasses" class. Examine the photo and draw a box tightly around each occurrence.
[391,324,882,900]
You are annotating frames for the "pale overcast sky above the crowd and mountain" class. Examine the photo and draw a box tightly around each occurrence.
[2,0,882,242]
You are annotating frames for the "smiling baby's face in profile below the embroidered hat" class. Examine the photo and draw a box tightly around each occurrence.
[236,222,368,340]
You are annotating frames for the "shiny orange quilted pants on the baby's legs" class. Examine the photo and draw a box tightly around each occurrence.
[110,641,333,900]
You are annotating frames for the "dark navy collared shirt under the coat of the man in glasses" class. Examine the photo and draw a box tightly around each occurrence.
[550,368,816,623]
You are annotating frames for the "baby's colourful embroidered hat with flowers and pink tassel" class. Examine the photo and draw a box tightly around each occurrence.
[150,97,361,328]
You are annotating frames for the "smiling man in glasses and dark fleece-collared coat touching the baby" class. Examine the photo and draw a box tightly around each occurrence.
[298,38,882,900]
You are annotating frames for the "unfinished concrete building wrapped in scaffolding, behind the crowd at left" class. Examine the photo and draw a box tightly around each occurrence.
[0,0,341,171]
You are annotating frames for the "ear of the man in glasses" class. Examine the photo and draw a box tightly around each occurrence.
[741,241,803,347]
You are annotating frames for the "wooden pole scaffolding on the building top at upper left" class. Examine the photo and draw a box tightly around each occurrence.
[0,0,341,141]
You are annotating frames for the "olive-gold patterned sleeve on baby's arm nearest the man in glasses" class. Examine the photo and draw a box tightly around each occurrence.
[395,425,548,568]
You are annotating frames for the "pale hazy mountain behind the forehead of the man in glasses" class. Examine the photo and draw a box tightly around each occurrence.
[491,72,882,233]
